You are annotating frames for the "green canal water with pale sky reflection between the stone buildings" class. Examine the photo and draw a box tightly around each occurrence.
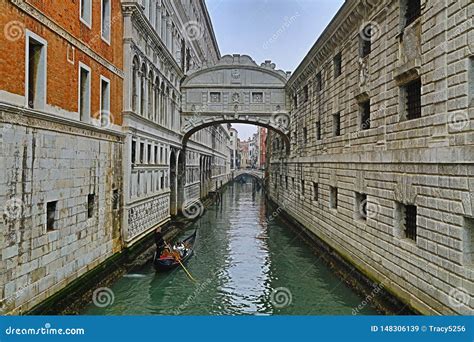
[83,180,377,315]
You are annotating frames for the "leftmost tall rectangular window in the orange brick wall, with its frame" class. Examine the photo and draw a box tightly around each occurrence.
[25,31,47,109]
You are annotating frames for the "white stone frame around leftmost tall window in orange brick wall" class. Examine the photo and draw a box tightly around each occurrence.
[25,30,48,109]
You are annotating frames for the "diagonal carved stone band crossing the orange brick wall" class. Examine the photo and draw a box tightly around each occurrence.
[10,0,124,78]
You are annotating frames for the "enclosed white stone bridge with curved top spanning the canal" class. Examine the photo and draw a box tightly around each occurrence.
[181,55,290,149]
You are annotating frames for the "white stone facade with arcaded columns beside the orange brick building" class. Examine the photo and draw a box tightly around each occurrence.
[122,0,229,245]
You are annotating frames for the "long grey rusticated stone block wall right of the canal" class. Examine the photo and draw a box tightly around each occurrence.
[269,1,474,314]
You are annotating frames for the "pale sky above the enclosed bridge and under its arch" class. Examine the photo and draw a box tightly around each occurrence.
[206,0,344,139]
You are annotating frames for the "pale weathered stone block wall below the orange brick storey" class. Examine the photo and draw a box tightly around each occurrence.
[0,106,122,313]
